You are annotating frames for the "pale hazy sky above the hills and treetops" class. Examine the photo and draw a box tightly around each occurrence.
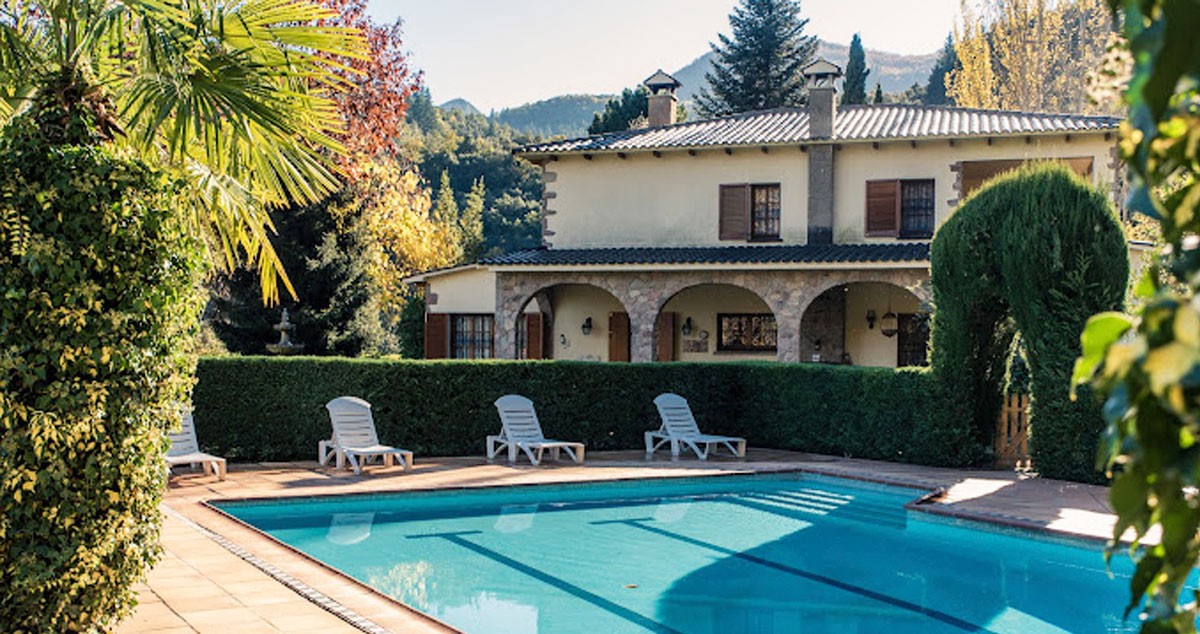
[370,0,959,113]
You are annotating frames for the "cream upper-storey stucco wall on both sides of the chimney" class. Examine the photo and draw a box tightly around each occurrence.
[546,133,1114,249]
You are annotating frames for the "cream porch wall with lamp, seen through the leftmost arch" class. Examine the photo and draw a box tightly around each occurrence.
[547,285,625,361]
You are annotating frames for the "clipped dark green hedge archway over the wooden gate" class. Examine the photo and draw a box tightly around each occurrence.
[920,163,1129,482]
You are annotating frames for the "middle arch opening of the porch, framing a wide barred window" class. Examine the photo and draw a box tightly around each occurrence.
[654,283,776,361]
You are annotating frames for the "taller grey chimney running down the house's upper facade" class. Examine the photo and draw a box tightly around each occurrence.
[804,59,841,245]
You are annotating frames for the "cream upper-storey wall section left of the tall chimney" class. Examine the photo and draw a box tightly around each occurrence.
[546,148,809,249]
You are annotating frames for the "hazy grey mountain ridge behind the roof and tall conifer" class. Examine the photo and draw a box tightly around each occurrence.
[671,40,937,101]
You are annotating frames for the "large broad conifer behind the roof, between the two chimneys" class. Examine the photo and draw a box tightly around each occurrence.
[696,0,817,116]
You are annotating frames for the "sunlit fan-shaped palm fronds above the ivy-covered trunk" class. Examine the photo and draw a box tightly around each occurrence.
[0,0,367,300]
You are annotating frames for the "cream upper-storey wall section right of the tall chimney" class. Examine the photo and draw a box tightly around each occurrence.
[833,134,1115,243]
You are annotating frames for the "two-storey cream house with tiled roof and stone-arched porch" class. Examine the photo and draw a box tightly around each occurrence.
[408,60,1121,366]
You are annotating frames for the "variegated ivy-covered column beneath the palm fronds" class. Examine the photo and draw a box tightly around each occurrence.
[0,82,198,632]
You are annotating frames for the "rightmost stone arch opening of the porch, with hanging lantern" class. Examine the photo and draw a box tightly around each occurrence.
[800,282,929,367]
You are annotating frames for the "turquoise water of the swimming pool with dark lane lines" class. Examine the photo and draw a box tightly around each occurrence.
[220,474,1152,634]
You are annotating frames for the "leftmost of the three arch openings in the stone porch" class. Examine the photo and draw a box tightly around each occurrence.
[516,283,629,361]
